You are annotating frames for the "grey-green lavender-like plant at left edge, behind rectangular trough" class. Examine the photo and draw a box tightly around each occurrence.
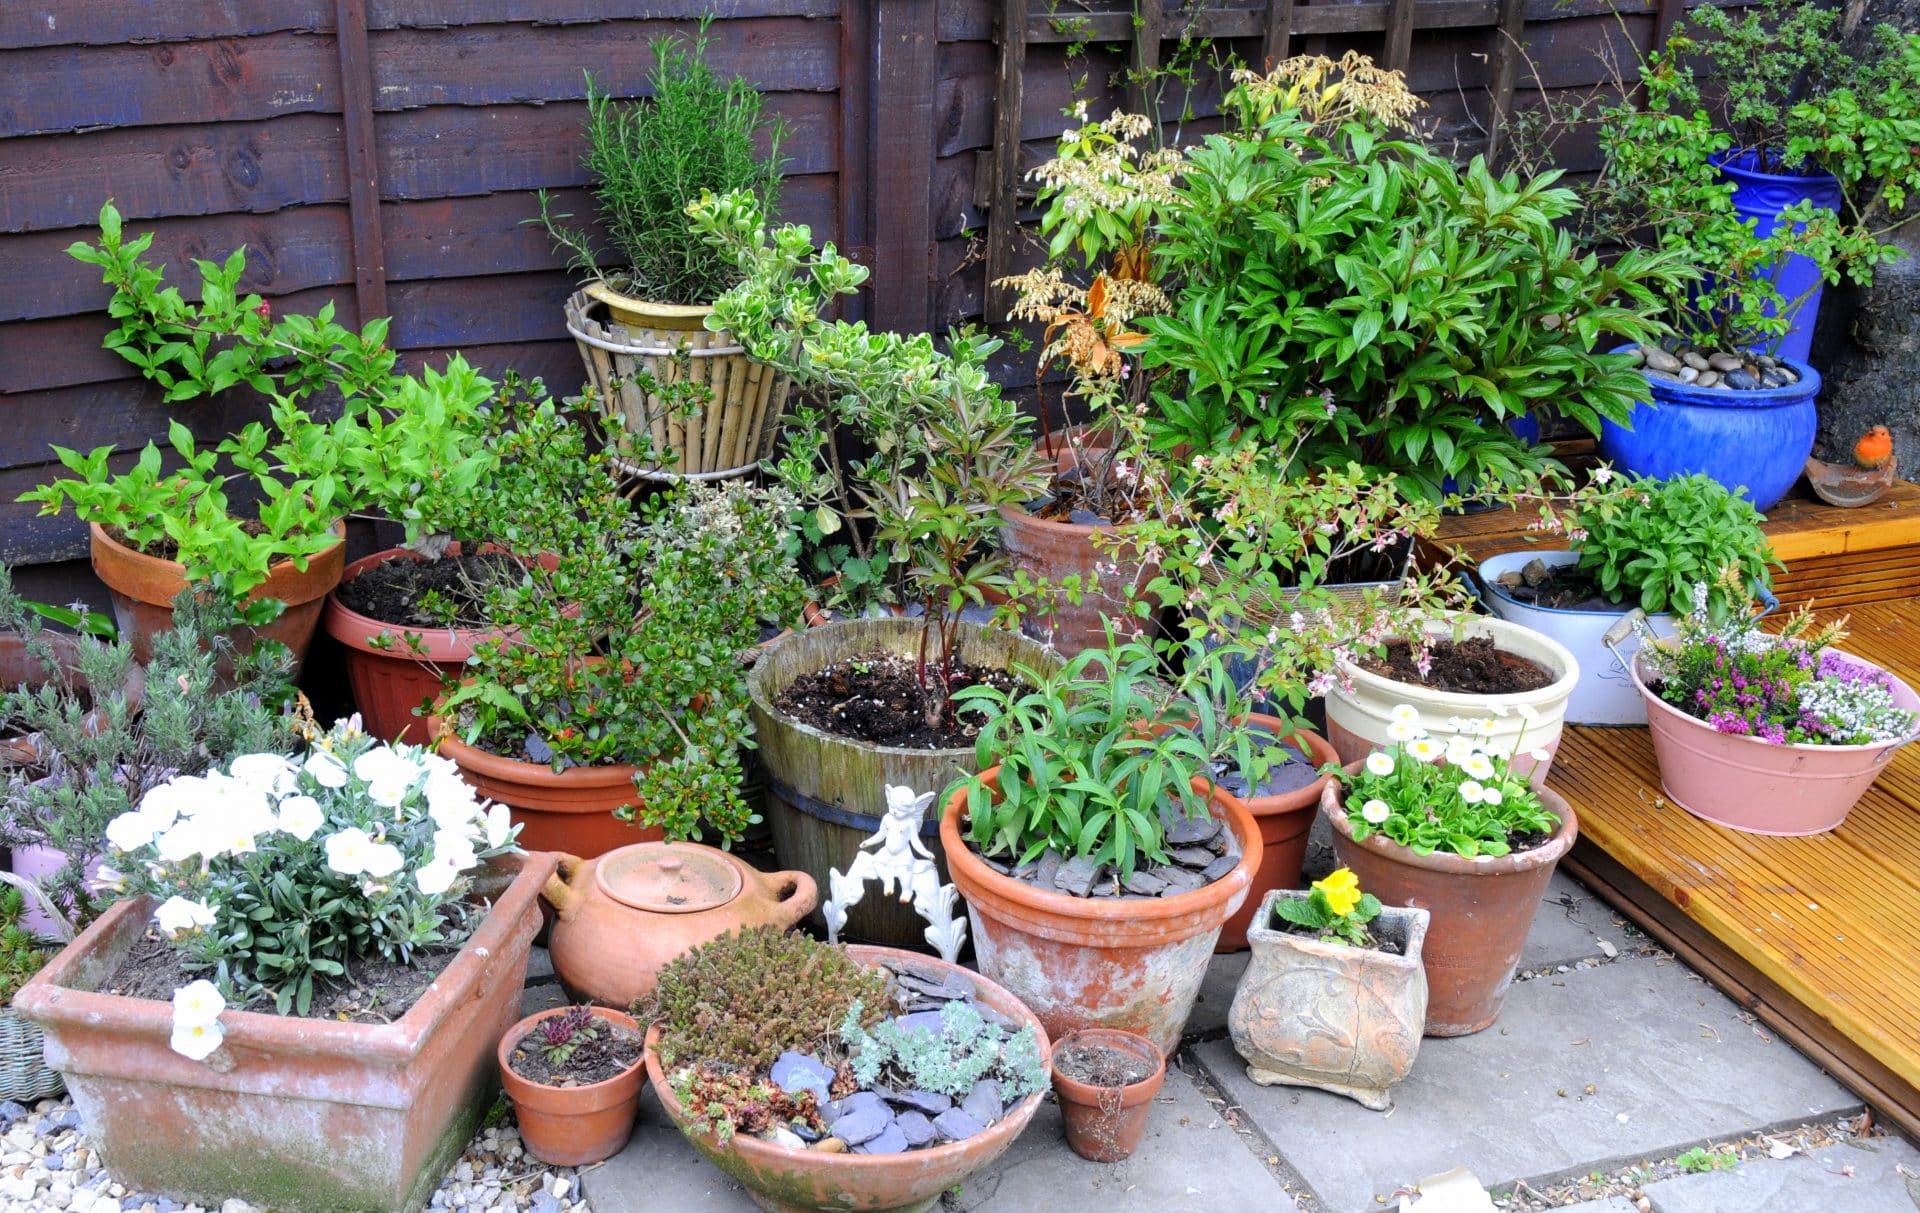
[0,568,294,927]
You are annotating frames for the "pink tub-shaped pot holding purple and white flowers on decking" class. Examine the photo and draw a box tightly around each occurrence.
[1634,649,1920,835]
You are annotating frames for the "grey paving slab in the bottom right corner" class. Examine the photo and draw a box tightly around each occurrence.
[1644,1138,1920,1213]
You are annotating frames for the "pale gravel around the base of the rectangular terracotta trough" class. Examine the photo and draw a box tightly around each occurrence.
[0,1098,591,1213]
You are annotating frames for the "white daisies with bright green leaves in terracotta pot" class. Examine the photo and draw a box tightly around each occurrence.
[1331,704,1559,860]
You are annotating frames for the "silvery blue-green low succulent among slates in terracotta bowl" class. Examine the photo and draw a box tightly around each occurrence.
[841,1002,1048,1104]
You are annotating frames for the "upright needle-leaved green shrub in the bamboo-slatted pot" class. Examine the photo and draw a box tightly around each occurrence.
[540,17,785,303]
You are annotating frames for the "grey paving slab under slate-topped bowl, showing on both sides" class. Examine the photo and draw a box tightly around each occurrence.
[580,1067,1298,1213]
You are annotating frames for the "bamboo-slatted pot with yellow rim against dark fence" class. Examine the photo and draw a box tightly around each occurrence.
[566,282,789,480]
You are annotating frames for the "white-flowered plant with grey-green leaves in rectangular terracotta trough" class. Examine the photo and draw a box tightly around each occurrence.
[100,718,518,1059]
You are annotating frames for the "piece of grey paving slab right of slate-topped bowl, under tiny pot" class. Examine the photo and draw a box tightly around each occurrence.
[948,1065,1298,1213]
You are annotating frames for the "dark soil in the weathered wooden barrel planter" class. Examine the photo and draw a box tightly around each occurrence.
[774,651,1016,750]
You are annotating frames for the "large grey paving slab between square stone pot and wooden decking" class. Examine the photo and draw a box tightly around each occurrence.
[1194,958,1859,1213]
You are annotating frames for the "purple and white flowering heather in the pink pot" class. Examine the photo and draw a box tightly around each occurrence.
[1638,582,1920,745]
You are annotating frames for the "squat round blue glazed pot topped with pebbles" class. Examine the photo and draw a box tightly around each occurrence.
[1599,359,1820,511]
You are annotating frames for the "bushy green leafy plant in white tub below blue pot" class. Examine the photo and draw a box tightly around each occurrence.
[1572,474,1780,622]
